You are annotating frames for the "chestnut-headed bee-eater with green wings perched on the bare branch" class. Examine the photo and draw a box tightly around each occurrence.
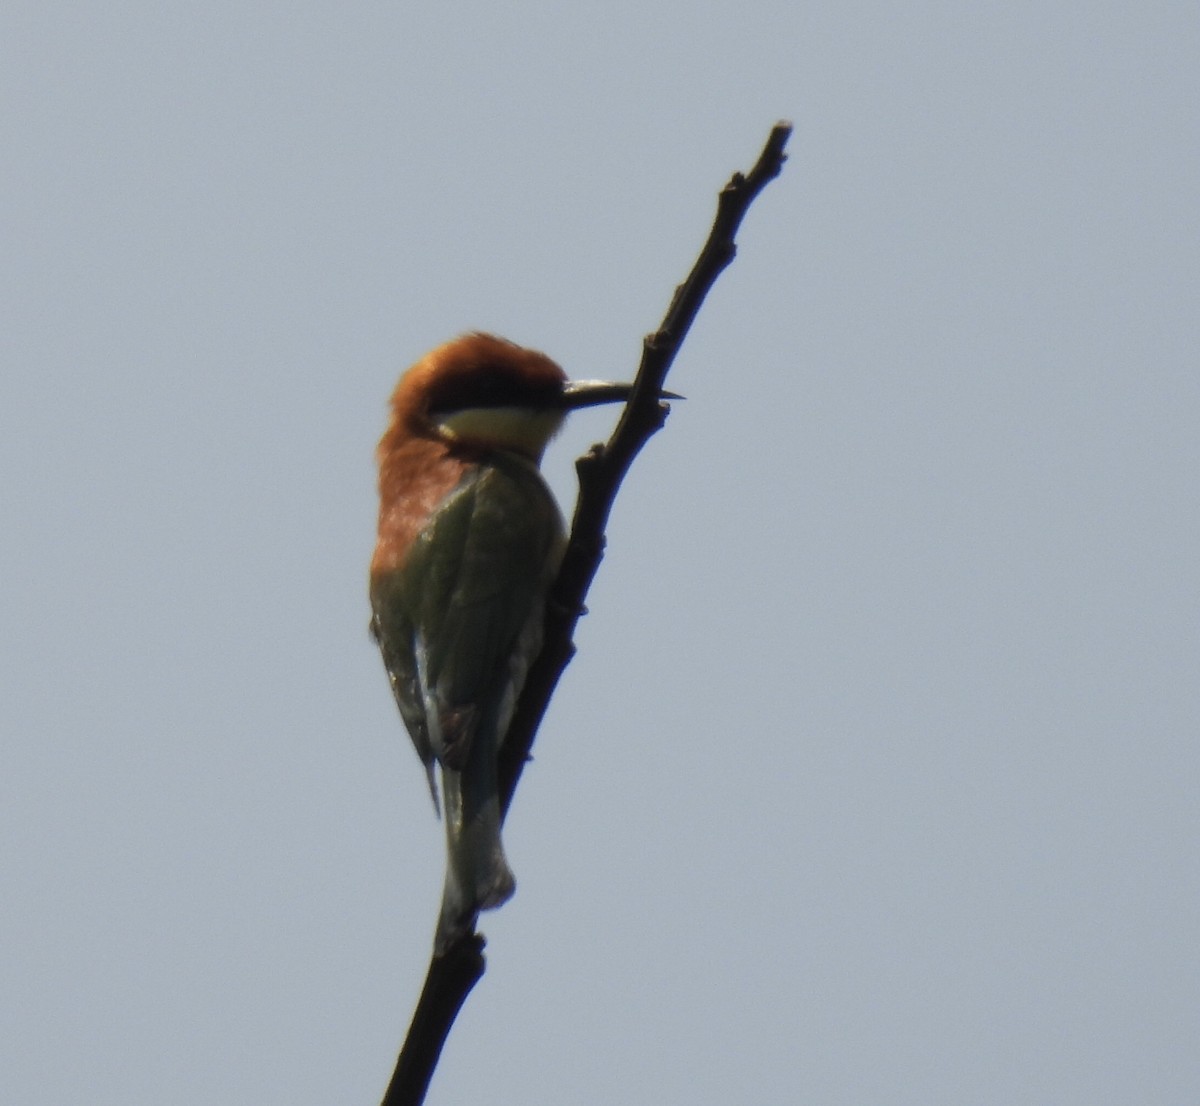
[370,332,648,955]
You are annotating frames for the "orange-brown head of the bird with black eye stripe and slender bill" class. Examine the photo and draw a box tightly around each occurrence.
[391,333,632,462]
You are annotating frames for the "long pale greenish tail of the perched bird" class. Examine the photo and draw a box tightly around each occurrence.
[433,741,516,956]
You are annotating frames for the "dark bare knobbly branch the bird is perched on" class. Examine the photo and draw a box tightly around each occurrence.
[382,122,792,1106]
